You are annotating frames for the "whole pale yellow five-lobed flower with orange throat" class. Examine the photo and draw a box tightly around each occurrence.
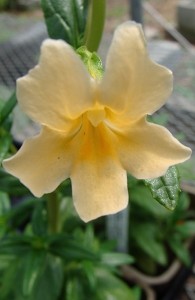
[3,22,191,221]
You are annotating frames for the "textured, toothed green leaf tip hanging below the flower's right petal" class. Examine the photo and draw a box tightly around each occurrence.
[144,167,180,210]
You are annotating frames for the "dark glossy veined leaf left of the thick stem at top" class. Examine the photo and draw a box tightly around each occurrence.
[41,0,88,49]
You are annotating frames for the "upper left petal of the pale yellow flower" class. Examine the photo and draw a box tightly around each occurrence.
[17,39,92,130]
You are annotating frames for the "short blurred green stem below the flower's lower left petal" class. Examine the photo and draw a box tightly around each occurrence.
[47,192,59,233]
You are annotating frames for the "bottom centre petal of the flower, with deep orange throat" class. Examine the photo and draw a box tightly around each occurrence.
[71,125,128,222]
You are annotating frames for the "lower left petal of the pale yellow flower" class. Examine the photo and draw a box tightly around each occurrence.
[3,127,77,197]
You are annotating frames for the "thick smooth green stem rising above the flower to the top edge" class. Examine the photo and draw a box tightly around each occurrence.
[84,0,106,52]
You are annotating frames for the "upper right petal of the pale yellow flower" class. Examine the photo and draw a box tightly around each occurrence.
[100,22,172,121]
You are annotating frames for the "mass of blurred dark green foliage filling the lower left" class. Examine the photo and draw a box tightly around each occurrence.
[0,192,139,300]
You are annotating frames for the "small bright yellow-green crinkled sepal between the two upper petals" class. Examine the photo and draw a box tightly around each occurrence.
[76,46,103,79]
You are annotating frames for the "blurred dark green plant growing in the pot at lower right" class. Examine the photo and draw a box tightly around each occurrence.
[129,176,195,274]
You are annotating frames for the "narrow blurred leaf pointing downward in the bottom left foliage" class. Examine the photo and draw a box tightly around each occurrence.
[22,250,47,297]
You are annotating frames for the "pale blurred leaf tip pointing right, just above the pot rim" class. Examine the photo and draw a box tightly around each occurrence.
[101,252,134,267]
